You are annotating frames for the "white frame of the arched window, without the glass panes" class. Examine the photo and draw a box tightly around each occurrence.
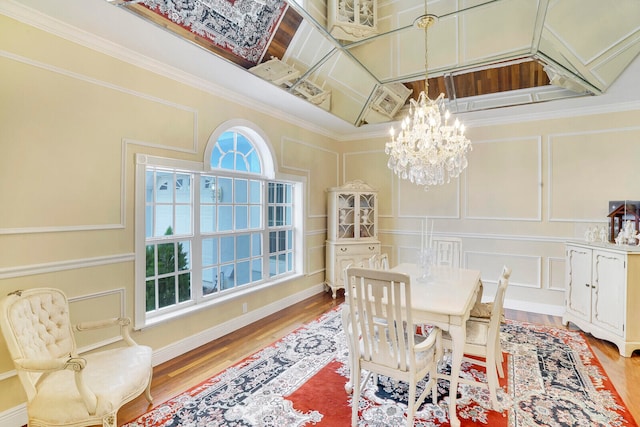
[134,121,306,329]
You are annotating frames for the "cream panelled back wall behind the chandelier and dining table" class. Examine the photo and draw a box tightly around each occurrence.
[342,110,640,314]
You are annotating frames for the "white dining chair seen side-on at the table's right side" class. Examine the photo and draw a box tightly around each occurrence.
[442,266,511,410]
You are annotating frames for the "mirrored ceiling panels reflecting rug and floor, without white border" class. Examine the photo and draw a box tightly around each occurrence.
[115,0,640,126]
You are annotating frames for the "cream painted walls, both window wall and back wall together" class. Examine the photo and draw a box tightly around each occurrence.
[0,6,640,422]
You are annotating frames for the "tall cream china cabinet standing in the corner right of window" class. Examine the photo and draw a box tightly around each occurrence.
[325,181,380,298]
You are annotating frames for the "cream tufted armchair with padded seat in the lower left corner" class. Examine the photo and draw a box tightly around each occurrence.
[0,288,152,427]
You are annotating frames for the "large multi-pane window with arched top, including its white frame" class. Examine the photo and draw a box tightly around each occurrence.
[136,121,302,327]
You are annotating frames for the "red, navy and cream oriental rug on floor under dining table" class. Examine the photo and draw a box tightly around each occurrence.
[125,307,637,427]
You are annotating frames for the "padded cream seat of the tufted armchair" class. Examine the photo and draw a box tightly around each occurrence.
[28,345,152,425]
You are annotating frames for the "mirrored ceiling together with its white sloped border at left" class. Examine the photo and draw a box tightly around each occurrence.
[5,0,640,139]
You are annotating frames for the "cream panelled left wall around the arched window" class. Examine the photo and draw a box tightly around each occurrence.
[0,15,341,414]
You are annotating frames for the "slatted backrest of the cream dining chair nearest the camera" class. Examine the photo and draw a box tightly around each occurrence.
[346,268,415,371]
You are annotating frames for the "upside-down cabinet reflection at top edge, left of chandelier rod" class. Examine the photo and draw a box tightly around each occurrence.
[328,0,378,41]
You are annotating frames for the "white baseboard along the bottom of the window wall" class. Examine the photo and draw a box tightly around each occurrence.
[0,284,325,427]
